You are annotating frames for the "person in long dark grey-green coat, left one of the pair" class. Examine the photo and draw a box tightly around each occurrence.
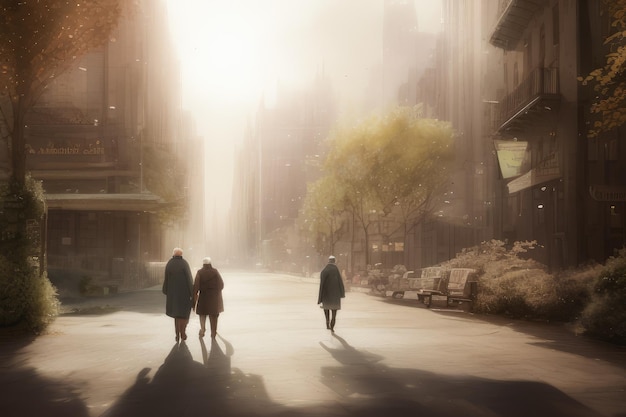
[163,248,193,342]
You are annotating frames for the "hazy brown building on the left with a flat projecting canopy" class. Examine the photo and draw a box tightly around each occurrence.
[4,1,199,288]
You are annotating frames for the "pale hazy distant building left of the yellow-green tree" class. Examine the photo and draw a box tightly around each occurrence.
[232,69,336,271]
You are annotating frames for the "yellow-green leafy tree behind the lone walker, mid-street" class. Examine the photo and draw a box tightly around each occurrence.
[325,107,454,264]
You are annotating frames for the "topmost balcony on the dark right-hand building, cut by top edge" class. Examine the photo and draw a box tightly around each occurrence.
[489,0,545,51]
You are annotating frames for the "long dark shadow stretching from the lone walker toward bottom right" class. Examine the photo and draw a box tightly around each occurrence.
[321,334,600,417]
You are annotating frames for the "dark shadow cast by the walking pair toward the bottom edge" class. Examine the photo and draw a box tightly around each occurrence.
[102,338,296,417]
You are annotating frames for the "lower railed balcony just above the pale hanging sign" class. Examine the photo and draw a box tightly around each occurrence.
[496,68,561,133]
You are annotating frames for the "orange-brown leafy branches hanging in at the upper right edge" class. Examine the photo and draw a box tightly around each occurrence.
[578,0,626,138]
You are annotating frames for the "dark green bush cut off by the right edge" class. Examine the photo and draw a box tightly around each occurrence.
[580,249,626,345]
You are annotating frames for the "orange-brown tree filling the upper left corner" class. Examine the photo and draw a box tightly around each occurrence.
[0,0,122,185]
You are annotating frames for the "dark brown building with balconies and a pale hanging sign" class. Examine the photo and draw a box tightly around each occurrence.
[489,0,626,268]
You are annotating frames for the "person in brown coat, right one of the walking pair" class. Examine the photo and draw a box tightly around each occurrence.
[193,258,224,339]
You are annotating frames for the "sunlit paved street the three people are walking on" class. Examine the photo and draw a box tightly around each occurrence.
[0,271,626,417]
